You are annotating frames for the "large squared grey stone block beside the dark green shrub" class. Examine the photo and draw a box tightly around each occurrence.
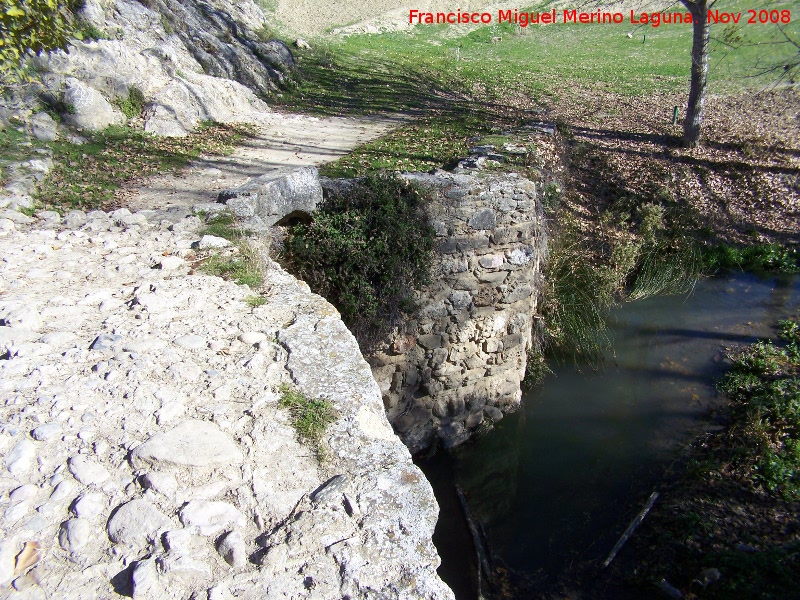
[217,167,323,226]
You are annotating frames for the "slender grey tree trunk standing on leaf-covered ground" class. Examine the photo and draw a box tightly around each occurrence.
[683,0,711,148]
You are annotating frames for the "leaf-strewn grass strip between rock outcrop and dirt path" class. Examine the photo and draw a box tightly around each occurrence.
[37,123,250,210]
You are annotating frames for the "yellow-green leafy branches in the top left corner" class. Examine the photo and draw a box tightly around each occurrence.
[0,0,72,85]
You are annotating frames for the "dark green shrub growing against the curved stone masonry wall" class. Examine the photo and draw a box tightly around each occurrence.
[284,175,435,342]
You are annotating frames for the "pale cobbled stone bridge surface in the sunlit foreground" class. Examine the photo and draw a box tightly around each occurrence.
[0,209,453,600]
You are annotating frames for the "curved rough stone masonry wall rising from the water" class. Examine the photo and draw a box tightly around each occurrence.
[372,171,546,452]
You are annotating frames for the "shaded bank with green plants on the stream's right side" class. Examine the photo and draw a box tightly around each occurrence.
[598,319,800,599]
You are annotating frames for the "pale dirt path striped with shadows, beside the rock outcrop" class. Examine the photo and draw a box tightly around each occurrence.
[125,114,405,211]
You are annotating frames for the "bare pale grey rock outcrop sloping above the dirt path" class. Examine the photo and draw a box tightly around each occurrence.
[36,0,294,136]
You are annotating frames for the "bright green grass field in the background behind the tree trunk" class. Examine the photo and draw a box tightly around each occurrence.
[275,0,800,118]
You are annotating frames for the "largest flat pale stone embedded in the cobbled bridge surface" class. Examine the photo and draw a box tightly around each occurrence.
[131,420,244,469]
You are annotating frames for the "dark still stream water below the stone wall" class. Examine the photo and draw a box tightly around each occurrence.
[418,274,800,600]
